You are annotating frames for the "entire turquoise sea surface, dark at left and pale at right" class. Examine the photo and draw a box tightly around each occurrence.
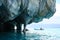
[0,28,60,40]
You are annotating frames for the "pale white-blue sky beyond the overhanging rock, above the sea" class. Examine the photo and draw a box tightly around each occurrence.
[27,0,60,28]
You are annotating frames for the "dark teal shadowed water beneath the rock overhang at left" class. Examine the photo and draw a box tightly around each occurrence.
[0,32,26,40]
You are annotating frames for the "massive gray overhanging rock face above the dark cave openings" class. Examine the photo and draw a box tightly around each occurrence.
[0,0,56,31]
